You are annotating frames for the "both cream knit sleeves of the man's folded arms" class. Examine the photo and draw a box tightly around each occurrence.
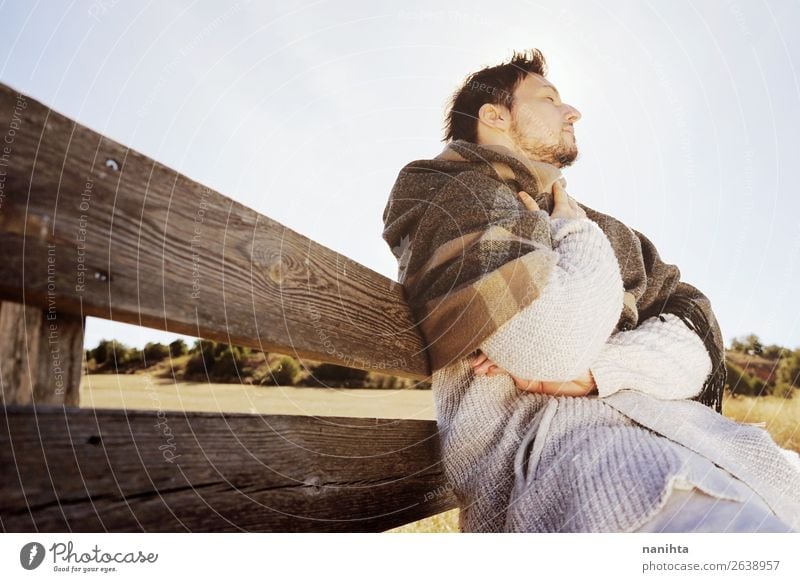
[480,218,711,398]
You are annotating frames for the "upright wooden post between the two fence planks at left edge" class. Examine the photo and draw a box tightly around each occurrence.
[0,301,85,406]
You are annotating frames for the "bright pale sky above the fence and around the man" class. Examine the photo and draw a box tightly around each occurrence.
[0,0,800,347]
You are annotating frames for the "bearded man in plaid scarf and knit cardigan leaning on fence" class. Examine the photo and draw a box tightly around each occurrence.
[383,50,800,531]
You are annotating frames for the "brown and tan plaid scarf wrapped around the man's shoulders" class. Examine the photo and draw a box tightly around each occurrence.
[383,140,725,412]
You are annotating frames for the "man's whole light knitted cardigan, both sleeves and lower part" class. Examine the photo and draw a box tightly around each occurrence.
[433,219,800,532]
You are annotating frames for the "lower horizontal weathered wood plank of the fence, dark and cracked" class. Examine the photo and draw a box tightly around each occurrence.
[0,406,456,532]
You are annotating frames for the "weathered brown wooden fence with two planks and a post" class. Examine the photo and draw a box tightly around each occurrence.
[0,84,456,532]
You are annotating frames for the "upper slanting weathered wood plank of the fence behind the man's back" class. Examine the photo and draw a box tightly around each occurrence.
[0,85,429,379]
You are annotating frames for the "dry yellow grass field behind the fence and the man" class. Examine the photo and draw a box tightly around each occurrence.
[81,374,800,533]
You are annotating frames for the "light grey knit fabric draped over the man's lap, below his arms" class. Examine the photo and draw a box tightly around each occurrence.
[433,359,800,532]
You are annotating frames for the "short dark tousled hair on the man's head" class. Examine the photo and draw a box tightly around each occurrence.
[442,49,547,143]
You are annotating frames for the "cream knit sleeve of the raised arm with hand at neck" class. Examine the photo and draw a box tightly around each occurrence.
[479,218,624,381]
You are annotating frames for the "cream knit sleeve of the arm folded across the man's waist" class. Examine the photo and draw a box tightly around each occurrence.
[590,313,711,400]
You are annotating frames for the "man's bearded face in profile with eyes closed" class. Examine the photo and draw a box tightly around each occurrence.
[509,74,581,168]
